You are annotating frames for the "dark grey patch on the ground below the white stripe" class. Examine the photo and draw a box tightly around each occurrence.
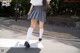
[6,48,41,53]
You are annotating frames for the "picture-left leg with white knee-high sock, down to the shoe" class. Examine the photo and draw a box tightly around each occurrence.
[26,19,37,42]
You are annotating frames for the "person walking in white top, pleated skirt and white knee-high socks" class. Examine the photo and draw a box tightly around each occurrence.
[25,0,50,47]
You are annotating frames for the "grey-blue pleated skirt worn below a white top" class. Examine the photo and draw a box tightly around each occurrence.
[28,6,46,22]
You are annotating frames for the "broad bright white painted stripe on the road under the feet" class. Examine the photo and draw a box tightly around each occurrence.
[0,38,43,48]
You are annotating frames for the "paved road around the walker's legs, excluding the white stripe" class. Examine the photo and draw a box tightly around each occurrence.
[0,18,80,53]
